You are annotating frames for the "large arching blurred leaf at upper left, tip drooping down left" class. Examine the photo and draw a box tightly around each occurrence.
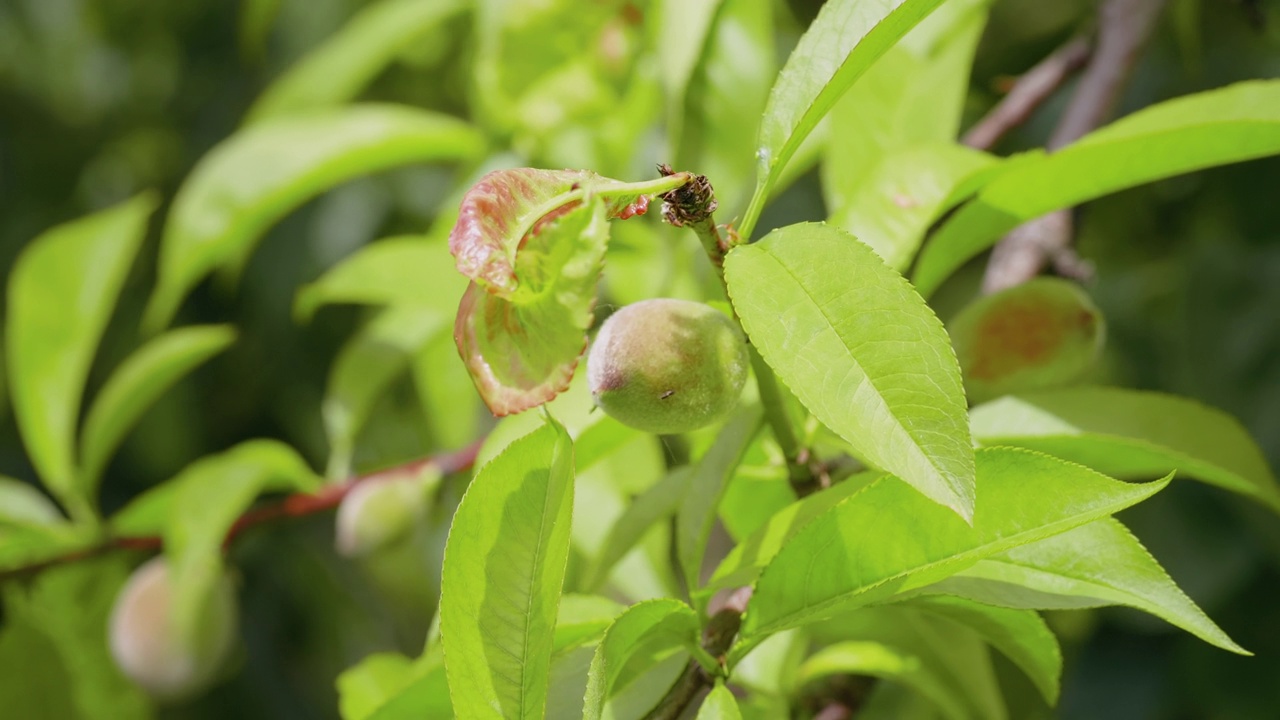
[143,105,484,331]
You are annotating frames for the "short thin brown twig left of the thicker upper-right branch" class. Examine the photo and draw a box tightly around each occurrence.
[961,37,1093,150]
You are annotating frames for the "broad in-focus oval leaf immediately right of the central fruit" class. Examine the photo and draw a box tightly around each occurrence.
[724,223,974,519]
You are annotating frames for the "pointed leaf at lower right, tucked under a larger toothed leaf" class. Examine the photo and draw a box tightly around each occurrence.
[923,519,1252,655]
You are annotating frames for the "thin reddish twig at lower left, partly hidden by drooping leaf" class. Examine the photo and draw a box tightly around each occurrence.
[0,441,483,583]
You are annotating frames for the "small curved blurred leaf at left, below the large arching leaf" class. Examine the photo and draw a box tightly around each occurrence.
[81,325,236,493]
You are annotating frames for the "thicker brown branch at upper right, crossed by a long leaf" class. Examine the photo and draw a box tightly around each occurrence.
[982,0,1165,293]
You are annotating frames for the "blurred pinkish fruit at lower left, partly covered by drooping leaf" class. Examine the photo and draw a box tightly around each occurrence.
[109,556,237,701]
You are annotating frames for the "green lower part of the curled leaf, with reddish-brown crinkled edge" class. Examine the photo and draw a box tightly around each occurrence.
[453,197,608,415]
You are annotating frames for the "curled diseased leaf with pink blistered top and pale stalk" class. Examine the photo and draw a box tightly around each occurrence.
[449,168,687,415]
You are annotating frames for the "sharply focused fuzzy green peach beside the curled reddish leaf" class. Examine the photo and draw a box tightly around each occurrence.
[586,299,750,434]
